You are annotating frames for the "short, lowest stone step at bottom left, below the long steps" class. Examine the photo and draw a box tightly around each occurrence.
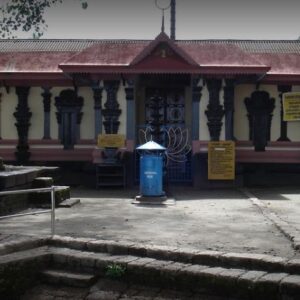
[41,269,96,287]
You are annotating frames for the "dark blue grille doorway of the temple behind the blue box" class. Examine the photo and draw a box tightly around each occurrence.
[137,77,192,183]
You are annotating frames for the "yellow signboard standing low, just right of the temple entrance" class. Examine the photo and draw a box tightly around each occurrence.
[208,141,235,180]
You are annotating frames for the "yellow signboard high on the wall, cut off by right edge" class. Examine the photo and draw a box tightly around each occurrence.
[282,93,300,121]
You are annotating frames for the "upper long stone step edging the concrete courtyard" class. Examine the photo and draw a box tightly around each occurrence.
[48,236,300,275]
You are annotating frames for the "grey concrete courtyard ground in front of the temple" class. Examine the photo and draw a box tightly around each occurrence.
[0,187,300,258]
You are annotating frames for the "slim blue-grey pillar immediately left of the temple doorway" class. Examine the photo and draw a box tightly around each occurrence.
[125,81,135,140]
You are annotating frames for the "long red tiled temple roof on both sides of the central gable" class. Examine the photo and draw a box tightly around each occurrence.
[0,35,300,76]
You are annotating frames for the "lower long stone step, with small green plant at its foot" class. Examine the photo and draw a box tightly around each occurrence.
[51,248,300,300]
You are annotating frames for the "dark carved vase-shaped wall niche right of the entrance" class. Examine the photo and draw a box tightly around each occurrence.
[245,91,275,151]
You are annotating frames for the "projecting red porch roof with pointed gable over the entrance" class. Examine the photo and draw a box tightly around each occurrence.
[60,33,269,73]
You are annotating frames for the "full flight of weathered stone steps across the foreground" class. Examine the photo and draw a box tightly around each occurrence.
[0,237,300,300]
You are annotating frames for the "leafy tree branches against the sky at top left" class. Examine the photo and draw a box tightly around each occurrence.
[0,0,88,38]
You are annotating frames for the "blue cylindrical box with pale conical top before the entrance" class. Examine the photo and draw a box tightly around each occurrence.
[136,141,166,200]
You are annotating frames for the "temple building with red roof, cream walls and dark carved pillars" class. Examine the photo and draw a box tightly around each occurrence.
[0,31,300,187]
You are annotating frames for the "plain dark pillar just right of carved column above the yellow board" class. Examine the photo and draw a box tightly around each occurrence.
[224,79,235,141]
